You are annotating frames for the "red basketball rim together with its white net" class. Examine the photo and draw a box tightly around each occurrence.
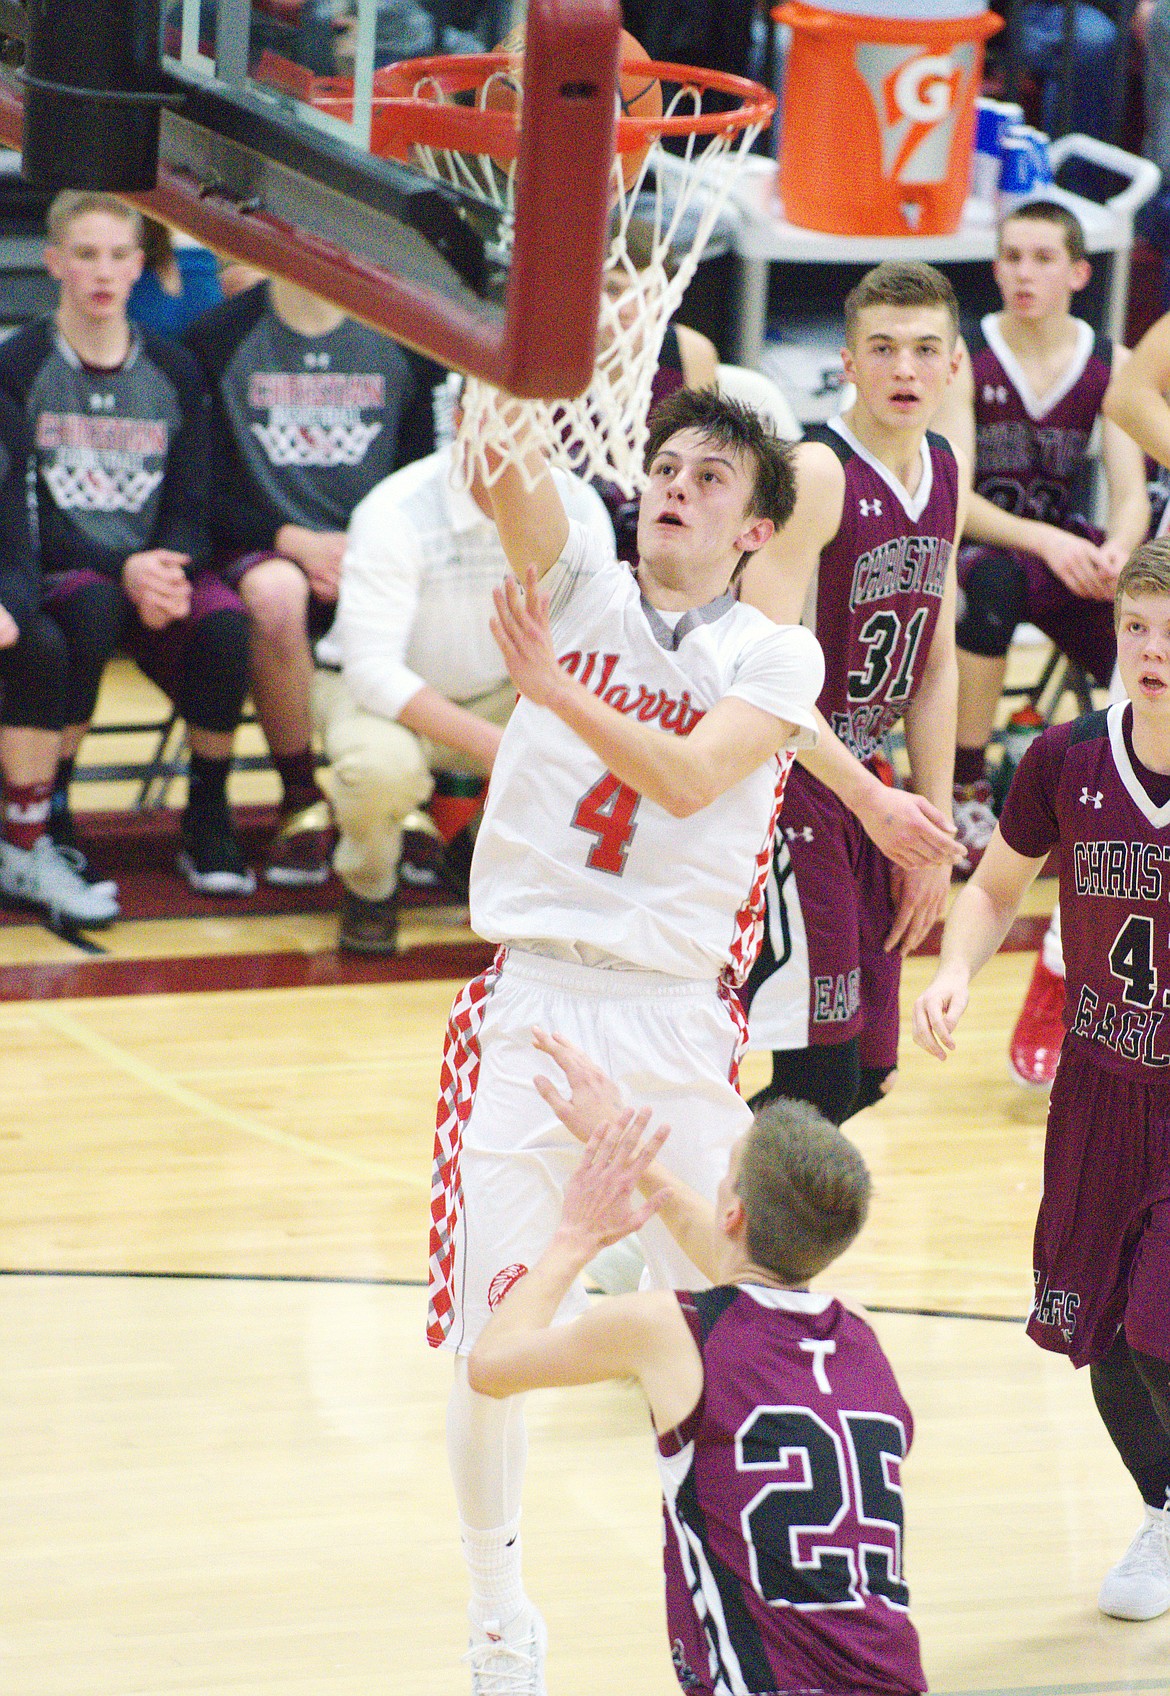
[262,53,775,495]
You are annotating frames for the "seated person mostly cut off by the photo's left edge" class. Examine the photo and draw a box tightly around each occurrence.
[0,392,119,926]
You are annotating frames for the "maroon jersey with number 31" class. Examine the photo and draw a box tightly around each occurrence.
[807,419,958,760]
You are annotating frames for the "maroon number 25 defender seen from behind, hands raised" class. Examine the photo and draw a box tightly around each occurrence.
[470,1031,926,1696]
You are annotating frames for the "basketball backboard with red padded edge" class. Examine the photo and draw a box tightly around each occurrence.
[0,0,621,397]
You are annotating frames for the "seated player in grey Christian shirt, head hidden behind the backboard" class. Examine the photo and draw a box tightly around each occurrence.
[187,278,436,889]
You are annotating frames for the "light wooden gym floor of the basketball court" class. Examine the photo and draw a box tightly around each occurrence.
[0,654,1170,1696]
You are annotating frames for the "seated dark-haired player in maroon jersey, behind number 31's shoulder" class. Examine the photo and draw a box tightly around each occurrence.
[934,200,1150,870]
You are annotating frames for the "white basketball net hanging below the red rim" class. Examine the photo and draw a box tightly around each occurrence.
[405,73,761,495]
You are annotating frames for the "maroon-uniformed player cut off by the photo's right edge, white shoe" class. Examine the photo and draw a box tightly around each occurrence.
[914,541,1170,1620]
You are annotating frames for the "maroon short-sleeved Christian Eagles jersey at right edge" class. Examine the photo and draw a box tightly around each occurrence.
[999,700,1170,1079]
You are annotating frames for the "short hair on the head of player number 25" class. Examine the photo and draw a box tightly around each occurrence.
[736,1097,870,1284]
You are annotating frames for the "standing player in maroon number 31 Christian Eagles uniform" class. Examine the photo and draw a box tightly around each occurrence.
[741,261,967,1124]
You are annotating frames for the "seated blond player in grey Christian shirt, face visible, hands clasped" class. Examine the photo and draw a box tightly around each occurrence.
[0,192,254,894]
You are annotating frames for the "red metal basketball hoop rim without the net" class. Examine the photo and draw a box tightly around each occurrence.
[342,53,777,159]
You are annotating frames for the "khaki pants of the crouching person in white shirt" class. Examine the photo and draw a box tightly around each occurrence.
[312,668,515,901]
